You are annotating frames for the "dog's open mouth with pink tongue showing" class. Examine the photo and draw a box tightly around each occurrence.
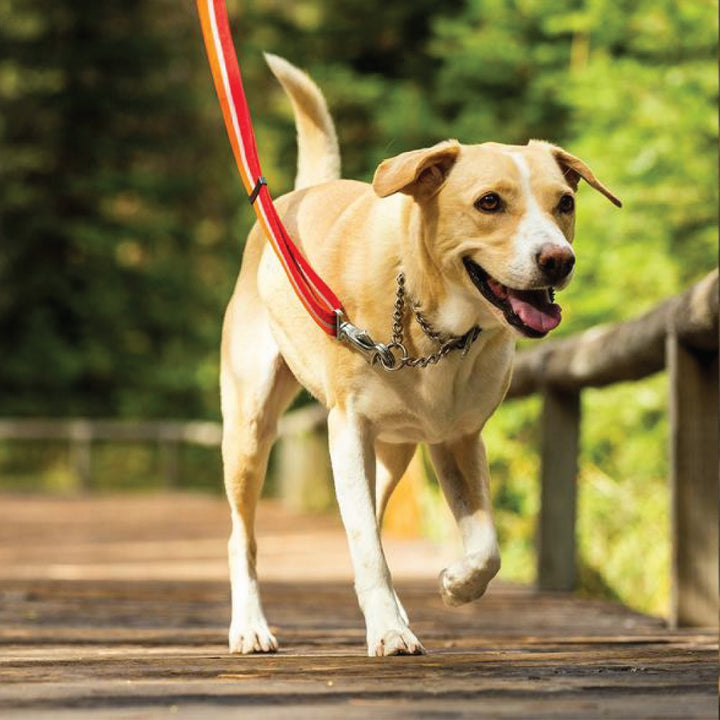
[463,257,562,338]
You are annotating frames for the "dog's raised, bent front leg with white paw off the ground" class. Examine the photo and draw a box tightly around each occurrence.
[430,434,500,605]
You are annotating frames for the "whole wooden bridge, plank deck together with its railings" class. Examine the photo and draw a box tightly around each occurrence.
[0,273,718,719]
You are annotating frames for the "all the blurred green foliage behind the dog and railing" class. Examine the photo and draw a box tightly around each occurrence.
[0,0,718,611]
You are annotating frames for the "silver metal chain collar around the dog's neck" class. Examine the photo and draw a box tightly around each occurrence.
[372,273,481,371]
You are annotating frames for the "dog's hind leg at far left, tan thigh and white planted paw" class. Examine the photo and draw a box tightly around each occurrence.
[220,303,299,654]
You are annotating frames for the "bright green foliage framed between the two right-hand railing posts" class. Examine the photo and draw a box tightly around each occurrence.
[578,373,670,614]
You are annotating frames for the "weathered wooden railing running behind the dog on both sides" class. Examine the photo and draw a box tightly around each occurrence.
[0,272,720,625]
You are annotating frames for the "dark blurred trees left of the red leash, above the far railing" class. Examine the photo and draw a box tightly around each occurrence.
[0,0,240,416]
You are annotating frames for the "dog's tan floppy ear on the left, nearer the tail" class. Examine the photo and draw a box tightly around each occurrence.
[373,140,460,199]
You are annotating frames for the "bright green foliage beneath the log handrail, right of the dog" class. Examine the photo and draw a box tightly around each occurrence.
[483,373,670,614]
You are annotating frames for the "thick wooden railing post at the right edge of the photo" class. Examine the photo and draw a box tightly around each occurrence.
[667,332,719,626]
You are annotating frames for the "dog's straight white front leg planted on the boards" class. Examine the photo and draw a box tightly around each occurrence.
[328,407,424,656]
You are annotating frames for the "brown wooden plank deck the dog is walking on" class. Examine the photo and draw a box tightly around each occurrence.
[0,494,717,720]
